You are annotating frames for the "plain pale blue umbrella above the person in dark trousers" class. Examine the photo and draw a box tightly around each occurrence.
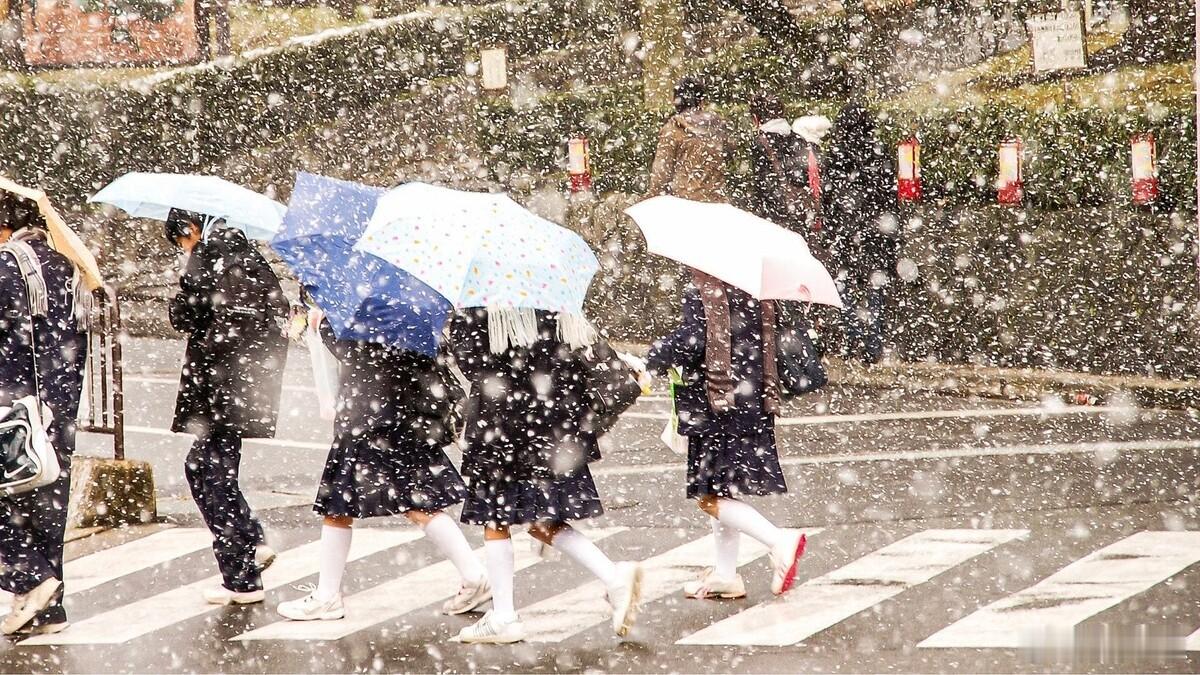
[88,172,287,241]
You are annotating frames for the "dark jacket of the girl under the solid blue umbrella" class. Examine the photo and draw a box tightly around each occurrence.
[320,321,463,456]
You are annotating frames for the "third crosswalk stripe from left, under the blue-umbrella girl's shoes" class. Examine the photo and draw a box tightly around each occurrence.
[234,527,626,640]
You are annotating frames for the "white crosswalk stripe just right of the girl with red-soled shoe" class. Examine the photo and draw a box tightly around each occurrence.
[676,530,1028,646]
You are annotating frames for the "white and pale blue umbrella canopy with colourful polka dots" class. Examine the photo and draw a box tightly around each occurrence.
[355,183,600,316]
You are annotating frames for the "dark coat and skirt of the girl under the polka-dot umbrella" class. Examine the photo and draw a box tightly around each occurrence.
[450,309,604,525]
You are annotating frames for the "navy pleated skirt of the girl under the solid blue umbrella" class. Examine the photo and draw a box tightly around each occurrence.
[313,442,467,518]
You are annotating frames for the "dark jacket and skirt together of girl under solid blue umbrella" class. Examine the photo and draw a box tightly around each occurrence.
[314,322,467,518]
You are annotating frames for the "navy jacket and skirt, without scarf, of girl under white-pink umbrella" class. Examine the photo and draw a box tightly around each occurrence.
[647,281,787,497]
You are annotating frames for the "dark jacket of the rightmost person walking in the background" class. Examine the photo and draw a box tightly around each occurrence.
[824,103,899,279]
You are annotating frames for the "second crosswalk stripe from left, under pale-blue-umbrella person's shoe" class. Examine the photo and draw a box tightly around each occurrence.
[20,527,421,645]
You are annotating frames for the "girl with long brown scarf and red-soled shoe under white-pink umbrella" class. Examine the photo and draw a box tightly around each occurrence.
[647,270,805,599]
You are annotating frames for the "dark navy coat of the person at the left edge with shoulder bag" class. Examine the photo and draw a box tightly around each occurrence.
[0,234,88,455]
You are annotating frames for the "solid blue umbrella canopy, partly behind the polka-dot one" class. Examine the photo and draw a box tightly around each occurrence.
[271,173,451,356]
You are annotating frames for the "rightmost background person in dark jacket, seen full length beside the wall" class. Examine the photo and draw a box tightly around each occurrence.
[823,101,900,363]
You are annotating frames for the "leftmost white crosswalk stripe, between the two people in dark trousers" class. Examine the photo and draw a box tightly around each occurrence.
[0,527,212,611]
